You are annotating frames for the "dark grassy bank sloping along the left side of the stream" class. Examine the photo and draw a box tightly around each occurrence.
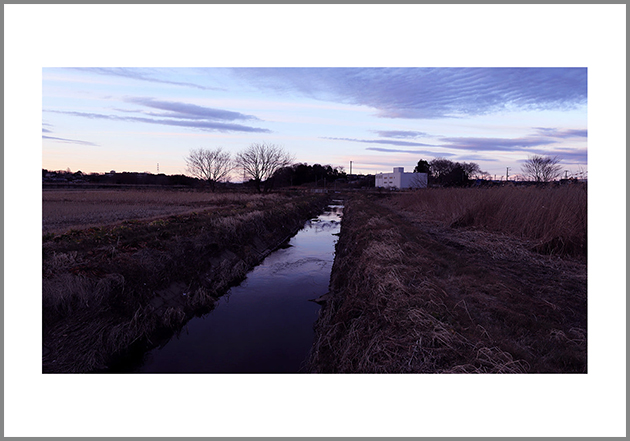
[43,190,325,372]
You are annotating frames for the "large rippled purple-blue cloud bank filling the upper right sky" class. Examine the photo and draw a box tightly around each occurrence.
[235,68,587,119]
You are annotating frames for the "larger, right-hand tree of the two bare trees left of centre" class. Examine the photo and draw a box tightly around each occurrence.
[236,143,293,192]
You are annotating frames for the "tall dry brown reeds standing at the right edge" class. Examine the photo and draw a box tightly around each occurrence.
[396,185,587,256]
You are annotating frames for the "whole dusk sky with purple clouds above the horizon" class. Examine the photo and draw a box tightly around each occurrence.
[42,67,588,180]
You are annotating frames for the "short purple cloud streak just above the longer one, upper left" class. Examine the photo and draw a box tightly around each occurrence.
[124,97,259,121]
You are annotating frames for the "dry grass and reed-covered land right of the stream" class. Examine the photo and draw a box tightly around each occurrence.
[310,189,586,373]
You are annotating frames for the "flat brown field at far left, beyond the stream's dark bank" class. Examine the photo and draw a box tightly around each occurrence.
[42,190,280,233]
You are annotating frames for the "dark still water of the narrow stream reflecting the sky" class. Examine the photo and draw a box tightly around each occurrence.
[136,201,343,373]
